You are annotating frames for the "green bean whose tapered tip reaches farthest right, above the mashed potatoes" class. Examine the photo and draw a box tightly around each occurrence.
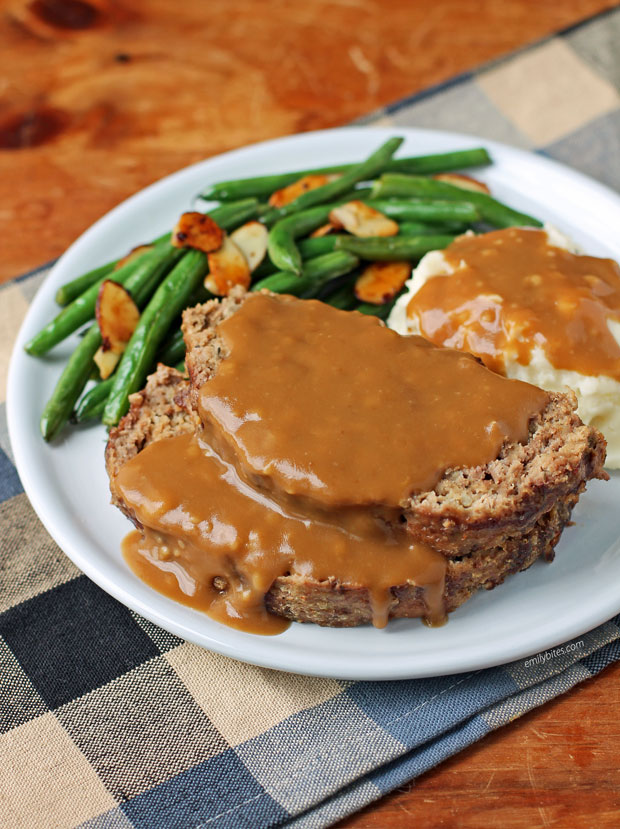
[373,173,542,227]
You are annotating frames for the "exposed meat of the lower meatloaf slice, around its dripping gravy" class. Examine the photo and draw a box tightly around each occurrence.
[106,360,604,627]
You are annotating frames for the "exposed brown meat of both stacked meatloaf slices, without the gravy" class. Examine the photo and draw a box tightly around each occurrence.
[106,308,604,627]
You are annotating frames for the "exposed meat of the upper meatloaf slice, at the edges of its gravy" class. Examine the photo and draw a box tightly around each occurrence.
[183,291,608,557]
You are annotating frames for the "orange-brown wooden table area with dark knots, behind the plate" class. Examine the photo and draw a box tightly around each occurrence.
[0,0,615,280]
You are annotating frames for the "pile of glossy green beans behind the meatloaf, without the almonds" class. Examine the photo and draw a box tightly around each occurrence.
[25,137,540,440]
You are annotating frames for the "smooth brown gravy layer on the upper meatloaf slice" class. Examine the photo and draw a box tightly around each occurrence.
[200,295,547,507]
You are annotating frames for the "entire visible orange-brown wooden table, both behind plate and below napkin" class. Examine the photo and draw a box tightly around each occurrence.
[0,0,620,829]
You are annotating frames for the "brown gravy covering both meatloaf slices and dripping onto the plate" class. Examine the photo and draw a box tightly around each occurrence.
[114,295,548,634]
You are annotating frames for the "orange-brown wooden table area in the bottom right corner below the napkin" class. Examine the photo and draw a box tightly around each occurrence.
[338,664,620,829]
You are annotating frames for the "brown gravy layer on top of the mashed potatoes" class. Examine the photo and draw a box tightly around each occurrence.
[407,228,620,380]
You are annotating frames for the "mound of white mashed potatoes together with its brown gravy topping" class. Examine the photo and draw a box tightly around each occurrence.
[388,228,620,468]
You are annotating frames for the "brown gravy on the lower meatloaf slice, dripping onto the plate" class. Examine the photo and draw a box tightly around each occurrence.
[116,435,445,633]
